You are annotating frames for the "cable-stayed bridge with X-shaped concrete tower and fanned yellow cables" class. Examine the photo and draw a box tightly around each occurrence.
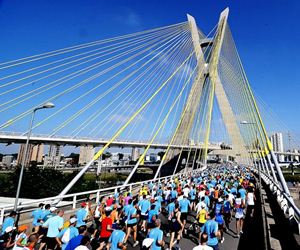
[0,9,300,248]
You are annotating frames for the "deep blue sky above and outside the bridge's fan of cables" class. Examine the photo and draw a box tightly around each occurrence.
[0,0,300,153]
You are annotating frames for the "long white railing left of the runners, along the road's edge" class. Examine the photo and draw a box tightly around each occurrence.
[0,171,197,225]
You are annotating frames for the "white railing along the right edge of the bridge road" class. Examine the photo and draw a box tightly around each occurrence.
[256,170,300,234]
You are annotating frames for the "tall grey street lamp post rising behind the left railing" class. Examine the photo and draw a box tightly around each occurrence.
[14,102,54,211]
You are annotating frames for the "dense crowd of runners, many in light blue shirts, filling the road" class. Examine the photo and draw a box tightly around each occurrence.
[0,166,256,250]
